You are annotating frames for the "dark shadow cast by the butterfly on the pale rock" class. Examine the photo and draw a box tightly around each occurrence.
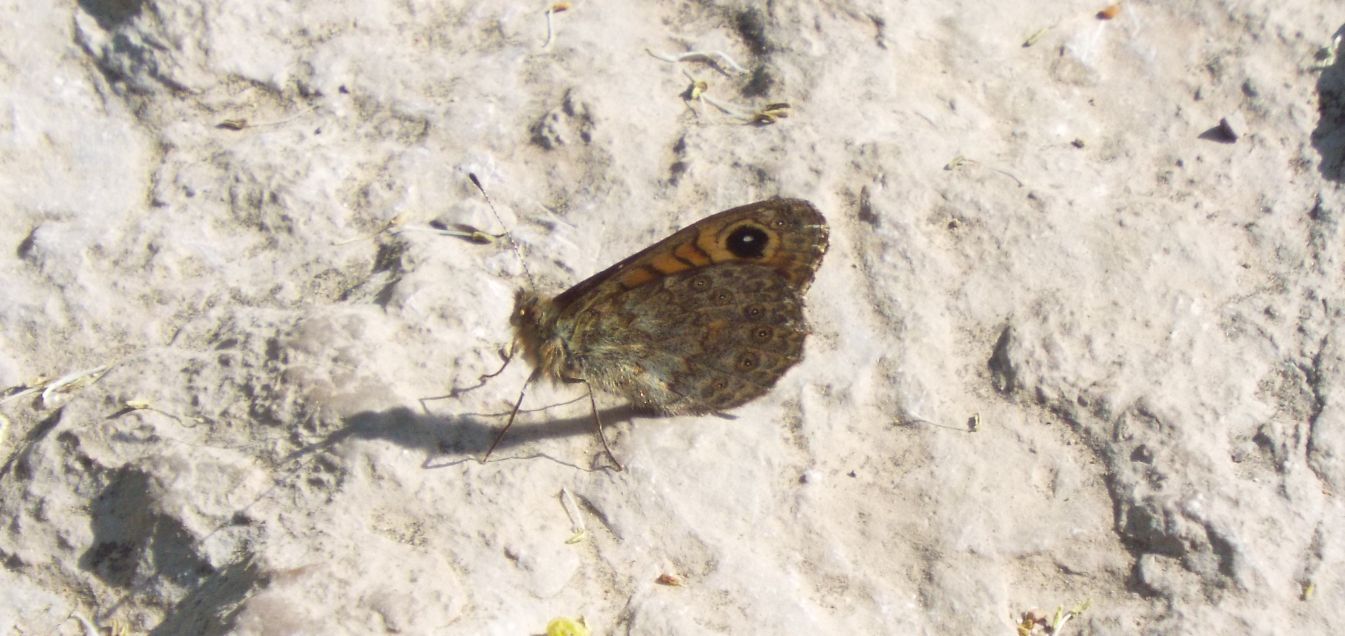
[288,405,648,469]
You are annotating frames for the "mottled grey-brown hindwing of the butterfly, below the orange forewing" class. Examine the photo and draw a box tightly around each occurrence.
[576,262,808,414]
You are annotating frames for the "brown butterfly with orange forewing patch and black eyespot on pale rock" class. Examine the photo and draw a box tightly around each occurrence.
[483,199,829,469]
